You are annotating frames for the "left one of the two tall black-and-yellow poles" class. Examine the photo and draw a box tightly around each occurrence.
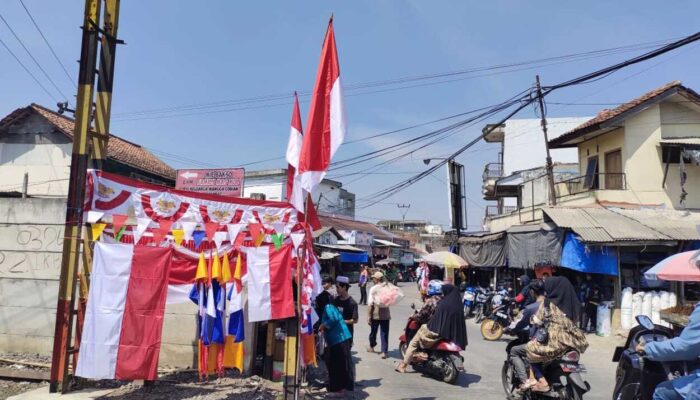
[49,0,100,393]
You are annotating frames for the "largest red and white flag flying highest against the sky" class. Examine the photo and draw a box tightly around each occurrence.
[298,18,347,193]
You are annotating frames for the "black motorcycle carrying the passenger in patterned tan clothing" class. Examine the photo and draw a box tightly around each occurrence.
[501,332,591,400]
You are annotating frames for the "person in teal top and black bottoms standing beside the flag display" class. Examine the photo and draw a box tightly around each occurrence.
[320,304,355,397]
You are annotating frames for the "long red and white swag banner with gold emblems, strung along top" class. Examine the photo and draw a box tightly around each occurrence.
[85,170,298,231]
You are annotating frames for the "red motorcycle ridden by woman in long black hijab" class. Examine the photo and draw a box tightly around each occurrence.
[399,304,464,384]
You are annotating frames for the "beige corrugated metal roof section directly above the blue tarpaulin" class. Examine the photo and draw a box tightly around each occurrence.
[544,207,678,243]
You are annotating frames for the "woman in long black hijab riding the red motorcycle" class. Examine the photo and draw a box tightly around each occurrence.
[396,284,467,373]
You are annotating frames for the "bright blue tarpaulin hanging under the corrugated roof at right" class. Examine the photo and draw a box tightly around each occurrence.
[560,232,617,276]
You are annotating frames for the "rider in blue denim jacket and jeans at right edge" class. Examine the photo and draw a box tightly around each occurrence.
[636,302,700,400]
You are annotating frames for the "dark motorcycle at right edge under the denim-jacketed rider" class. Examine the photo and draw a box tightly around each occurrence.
[612,315,699,400]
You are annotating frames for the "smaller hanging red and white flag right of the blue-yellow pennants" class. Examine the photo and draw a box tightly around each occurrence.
[246,244,294,322]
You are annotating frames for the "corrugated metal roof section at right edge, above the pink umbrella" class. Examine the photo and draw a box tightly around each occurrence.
[615,210,700,240]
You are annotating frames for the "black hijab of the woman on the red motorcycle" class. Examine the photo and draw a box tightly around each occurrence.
[428,284,467,349]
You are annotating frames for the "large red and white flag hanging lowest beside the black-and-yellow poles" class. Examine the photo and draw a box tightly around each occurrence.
[75,242,173,380]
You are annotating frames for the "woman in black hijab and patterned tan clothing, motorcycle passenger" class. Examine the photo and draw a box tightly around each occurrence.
[527,276,588,392]
